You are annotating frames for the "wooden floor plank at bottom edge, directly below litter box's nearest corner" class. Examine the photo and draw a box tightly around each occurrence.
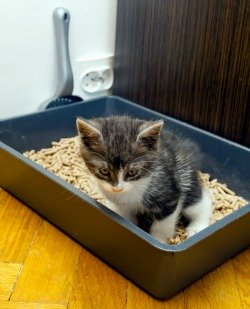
[126,283,184,309]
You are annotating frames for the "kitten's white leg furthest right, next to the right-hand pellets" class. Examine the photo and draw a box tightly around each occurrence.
[184,188,212,237]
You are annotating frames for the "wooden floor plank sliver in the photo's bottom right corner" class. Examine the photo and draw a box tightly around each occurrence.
[232,248,250,308]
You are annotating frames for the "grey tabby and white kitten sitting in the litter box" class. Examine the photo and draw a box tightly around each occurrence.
[77,116,212,242]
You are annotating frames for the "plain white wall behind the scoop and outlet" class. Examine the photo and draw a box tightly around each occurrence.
[0,0,116,119]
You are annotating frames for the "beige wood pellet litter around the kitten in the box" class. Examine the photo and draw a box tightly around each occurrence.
[24,136,247,244]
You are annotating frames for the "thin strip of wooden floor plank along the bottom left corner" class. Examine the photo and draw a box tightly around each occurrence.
[0,301,67,309]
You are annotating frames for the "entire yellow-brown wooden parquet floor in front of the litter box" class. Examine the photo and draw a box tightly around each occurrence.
[0,188,250,309]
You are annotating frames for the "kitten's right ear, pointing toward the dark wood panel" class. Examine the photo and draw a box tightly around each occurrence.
[137,120,164,148]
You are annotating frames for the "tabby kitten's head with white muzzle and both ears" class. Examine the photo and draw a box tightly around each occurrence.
[76,116,163,196]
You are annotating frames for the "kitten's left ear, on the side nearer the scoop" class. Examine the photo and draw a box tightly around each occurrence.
[76,118,102,148]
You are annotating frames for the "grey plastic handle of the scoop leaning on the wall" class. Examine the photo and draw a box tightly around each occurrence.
[53,7,74,97]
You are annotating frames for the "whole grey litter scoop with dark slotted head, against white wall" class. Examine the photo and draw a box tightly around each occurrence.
[38,8,83,110]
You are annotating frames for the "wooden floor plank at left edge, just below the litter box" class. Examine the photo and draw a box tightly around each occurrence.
[0,188,42,263]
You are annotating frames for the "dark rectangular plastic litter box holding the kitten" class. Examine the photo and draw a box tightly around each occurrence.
[0,96,250,299]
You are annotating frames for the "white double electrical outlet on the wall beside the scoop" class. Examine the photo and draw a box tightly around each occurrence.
[74,55,114,99]
